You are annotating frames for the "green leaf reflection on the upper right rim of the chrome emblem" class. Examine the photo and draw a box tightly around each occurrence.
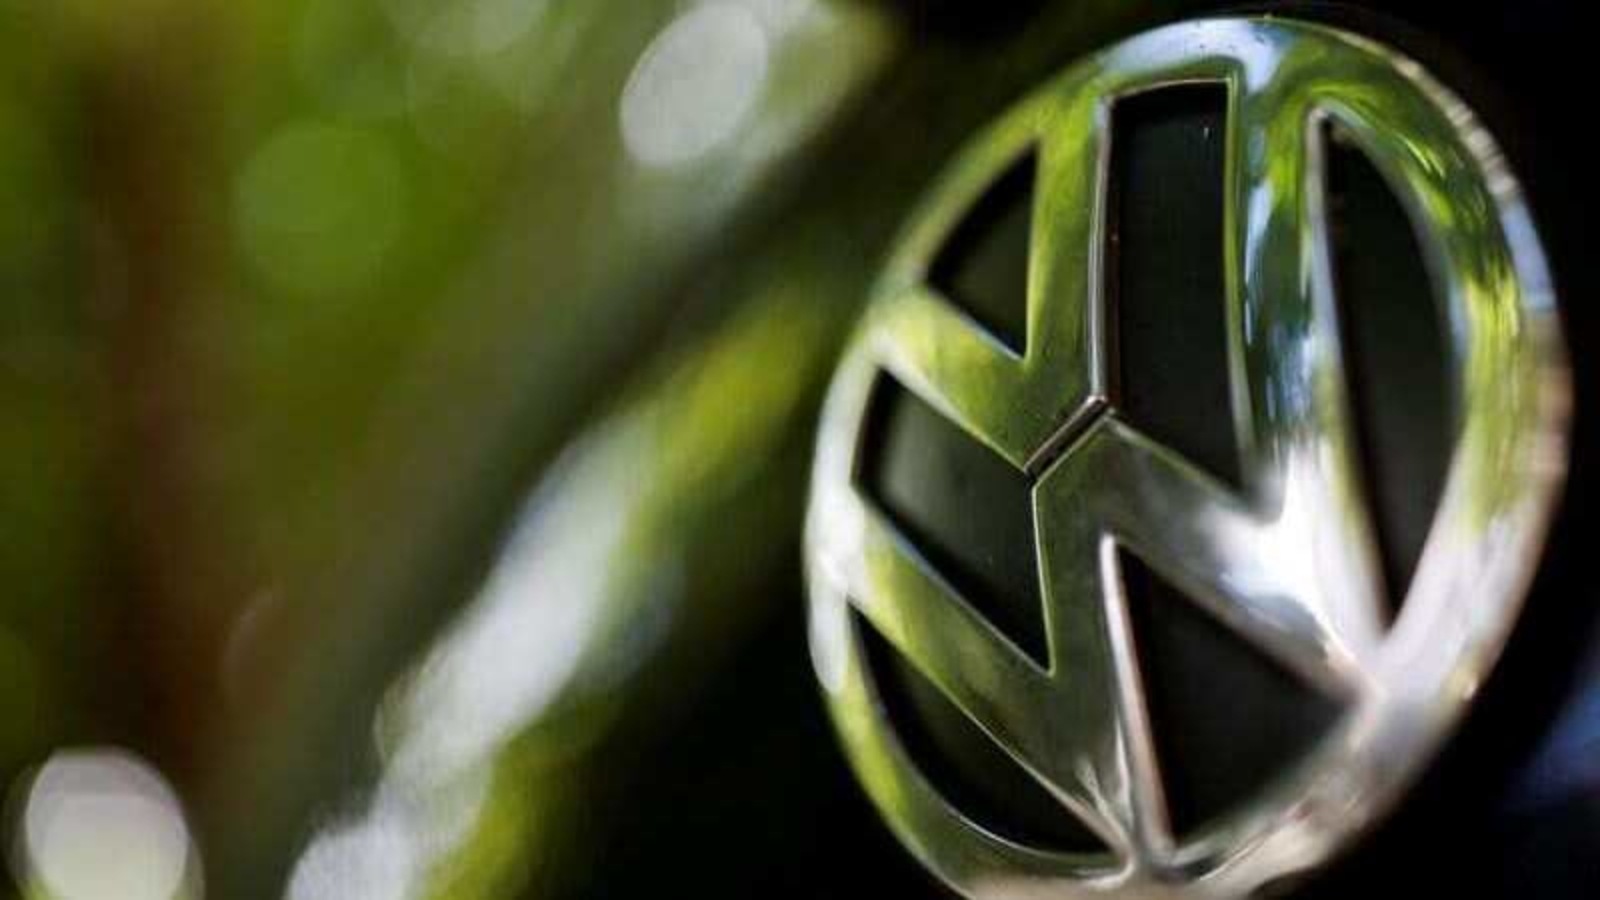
[1246,31,1560,530]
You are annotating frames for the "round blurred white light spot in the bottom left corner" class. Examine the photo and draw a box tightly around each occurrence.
[13,749,200,900]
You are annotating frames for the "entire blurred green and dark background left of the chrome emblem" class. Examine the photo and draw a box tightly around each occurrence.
[0,0,1173,898]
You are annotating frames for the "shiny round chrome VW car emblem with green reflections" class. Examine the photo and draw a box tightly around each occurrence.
[806,18,1568,897]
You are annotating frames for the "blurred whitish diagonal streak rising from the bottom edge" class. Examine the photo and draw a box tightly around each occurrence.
[288,420,677,900]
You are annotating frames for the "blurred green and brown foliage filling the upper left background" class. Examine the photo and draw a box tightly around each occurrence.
[0,0,885,895]
